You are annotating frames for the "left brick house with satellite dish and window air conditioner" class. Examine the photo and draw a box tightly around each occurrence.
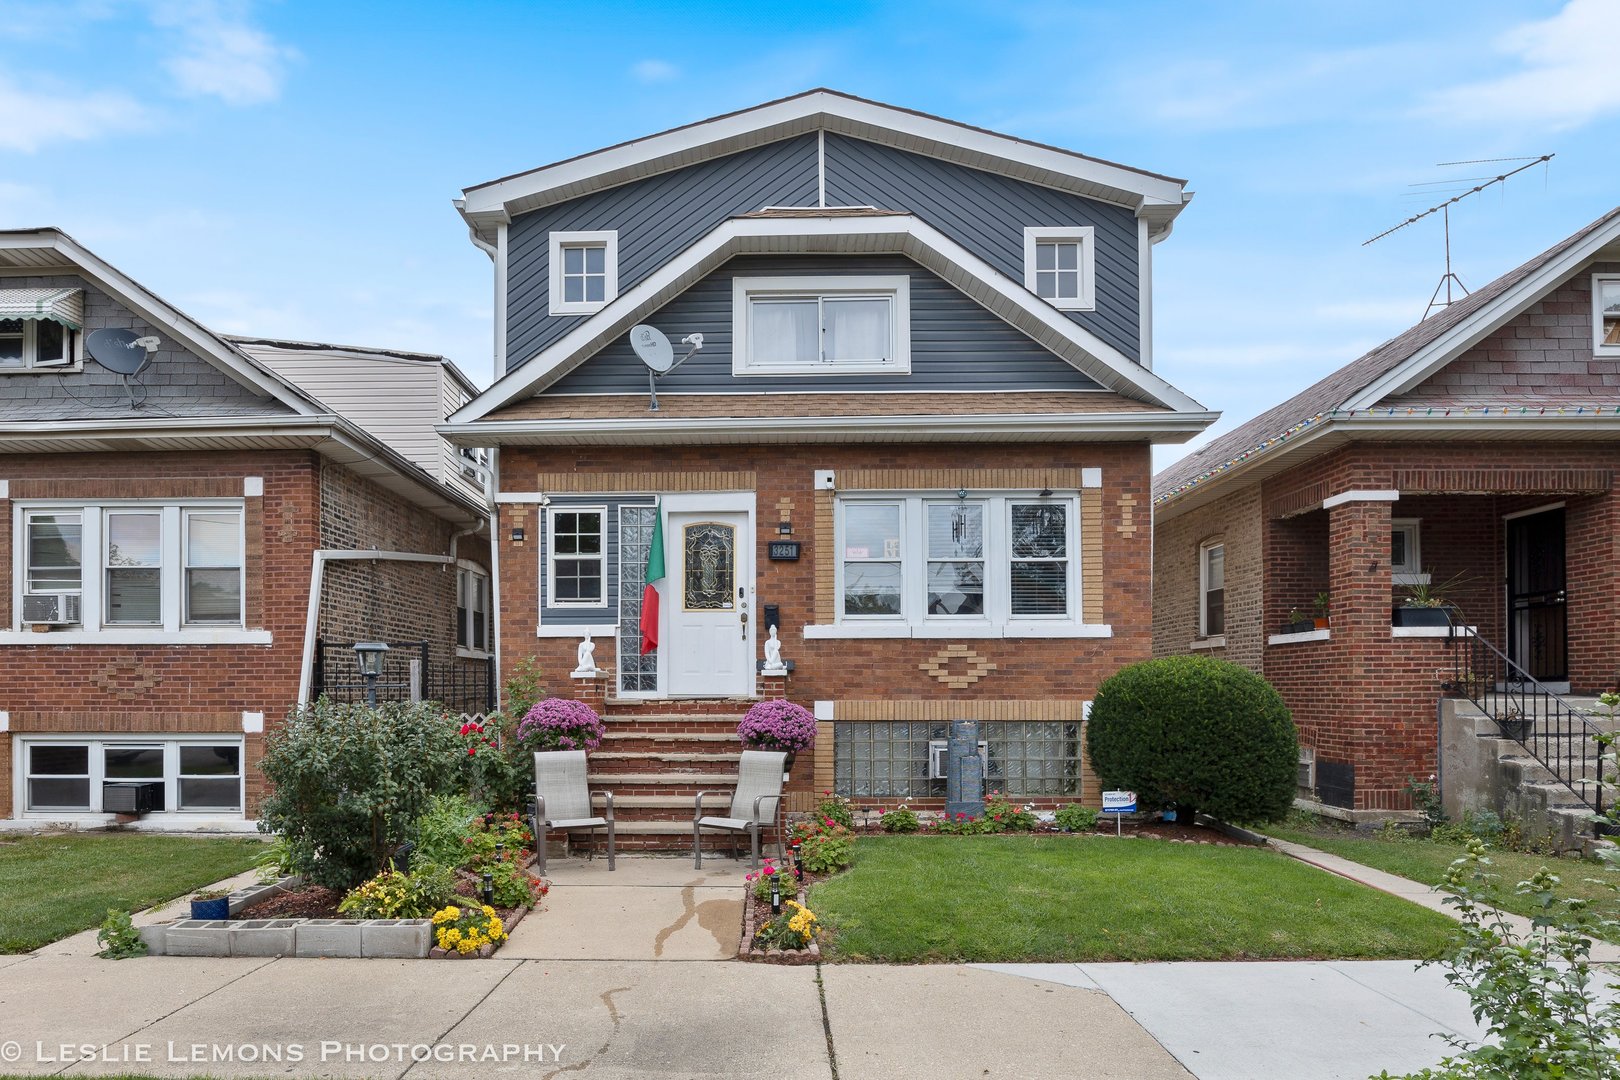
[0,228,489,829]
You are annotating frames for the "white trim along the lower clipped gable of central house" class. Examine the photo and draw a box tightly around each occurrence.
[450,214,1205,424]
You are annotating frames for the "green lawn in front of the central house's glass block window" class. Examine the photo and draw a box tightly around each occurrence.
[808,836,1455,963]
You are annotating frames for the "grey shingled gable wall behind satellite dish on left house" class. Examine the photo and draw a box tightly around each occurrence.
[0,274,292,421]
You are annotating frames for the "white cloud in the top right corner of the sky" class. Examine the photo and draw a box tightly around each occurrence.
[1422,0,1620,130]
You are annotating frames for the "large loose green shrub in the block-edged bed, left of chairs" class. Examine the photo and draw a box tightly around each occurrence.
[259,698,465,891]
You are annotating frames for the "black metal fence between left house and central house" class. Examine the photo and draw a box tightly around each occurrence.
[309,640,496,716]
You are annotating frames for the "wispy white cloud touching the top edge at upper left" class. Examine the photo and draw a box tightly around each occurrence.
[152,0,298,105]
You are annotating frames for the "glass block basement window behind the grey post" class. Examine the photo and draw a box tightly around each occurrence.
[833,721,1081,798]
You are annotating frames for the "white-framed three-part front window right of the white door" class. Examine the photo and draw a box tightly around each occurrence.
[838,494,1081,636]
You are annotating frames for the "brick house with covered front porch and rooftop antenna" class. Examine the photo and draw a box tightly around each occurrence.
[1153,210,1620,811]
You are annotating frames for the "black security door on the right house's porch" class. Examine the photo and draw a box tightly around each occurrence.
[1508,508,1570,682]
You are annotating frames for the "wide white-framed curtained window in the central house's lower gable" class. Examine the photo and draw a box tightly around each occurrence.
[732,274,910,376]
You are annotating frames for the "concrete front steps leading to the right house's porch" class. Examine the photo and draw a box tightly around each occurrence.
[1440,696,1615,852]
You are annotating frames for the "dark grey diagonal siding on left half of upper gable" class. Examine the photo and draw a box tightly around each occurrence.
[507,134,816,369]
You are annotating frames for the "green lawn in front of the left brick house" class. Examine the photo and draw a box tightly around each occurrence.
[0,832,264,954]
